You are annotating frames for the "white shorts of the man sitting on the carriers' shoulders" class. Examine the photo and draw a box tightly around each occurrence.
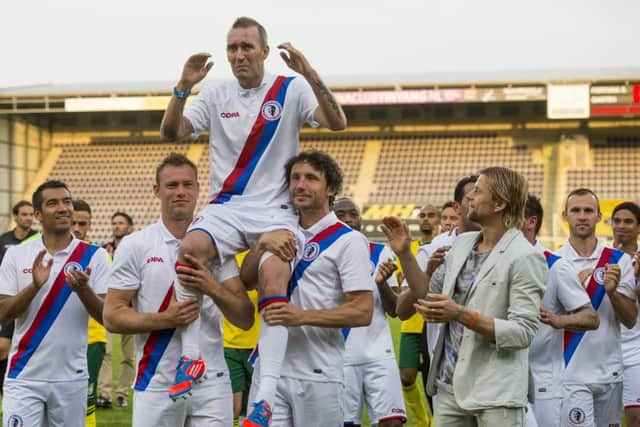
[187,203,305,263]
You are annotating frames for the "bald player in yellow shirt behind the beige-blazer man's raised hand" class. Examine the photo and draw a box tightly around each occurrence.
[398,205,441,427]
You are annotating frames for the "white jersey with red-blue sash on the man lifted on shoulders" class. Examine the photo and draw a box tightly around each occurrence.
[184,74,318,208]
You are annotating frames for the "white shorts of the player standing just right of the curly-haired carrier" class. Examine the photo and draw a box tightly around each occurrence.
[344,358,407,424]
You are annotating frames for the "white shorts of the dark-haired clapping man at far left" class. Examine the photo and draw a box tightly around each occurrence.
[2,379,89,427]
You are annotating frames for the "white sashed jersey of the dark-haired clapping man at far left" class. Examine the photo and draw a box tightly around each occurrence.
[0,237,111,381]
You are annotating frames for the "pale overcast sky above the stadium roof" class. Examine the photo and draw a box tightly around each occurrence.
[0,0,640,87]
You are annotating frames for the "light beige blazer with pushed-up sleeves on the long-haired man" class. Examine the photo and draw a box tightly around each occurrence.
[427,228,548,410]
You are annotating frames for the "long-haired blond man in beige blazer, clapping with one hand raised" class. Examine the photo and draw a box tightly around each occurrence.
[382,167,548,427]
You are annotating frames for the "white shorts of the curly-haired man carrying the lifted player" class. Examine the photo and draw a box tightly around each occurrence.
[249,372,344,427]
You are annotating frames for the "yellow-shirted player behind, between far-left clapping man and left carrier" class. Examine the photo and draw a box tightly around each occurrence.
[71,199,107,427]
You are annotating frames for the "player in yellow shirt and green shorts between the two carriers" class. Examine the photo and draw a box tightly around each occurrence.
[222,251,260,427]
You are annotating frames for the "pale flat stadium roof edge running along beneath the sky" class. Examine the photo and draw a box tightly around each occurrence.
[0,67,640,96]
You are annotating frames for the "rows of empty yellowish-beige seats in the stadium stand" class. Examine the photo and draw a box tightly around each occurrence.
[33,133,640,246]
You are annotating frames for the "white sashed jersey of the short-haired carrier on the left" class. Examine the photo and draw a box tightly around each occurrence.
[109,220,238,391]
